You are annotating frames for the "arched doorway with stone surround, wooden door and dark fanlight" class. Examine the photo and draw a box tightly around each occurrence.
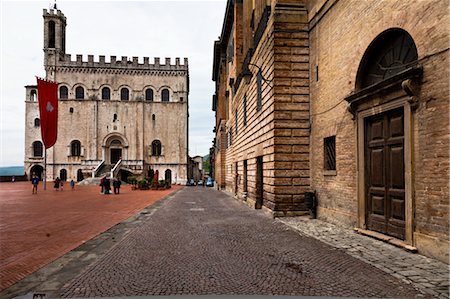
[346,28,422,244]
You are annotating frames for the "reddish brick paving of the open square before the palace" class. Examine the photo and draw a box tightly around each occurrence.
[0,182,180,290]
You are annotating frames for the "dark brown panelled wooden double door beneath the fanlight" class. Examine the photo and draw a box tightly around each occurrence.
[365,108,405,240]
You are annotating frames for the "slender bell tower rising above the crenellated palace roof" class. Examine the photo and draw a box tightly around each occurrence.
[43,4,66,72]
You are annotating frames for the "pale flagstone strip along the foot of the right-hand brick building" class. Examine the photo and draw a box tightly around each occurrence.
[278,217,449,298]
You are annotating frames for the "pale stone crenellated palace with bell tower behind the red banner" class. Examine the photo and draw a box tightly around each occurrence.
[25,10,189,184]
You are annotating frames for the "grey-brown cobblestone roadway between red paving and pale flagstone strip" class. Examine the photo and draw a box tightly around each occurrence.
[60,187,431,298]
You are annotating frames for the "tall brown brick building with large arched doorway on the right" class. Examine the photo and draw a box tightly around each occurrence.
[213,0,449,262]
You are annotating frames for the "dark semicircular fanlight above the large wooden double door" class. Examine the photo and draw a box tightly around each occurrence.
[356,28,418,89]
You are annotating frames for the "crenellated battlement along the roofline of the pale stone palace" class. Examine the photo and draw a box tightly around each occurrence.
[58,54,188,71]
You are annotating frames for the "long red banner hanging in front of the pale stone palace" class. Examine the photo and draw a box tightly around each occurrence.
[37,78,58,148]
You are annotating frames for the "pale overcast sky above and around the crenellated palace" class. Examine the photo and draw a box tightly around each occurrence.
[0,0,226,166]
